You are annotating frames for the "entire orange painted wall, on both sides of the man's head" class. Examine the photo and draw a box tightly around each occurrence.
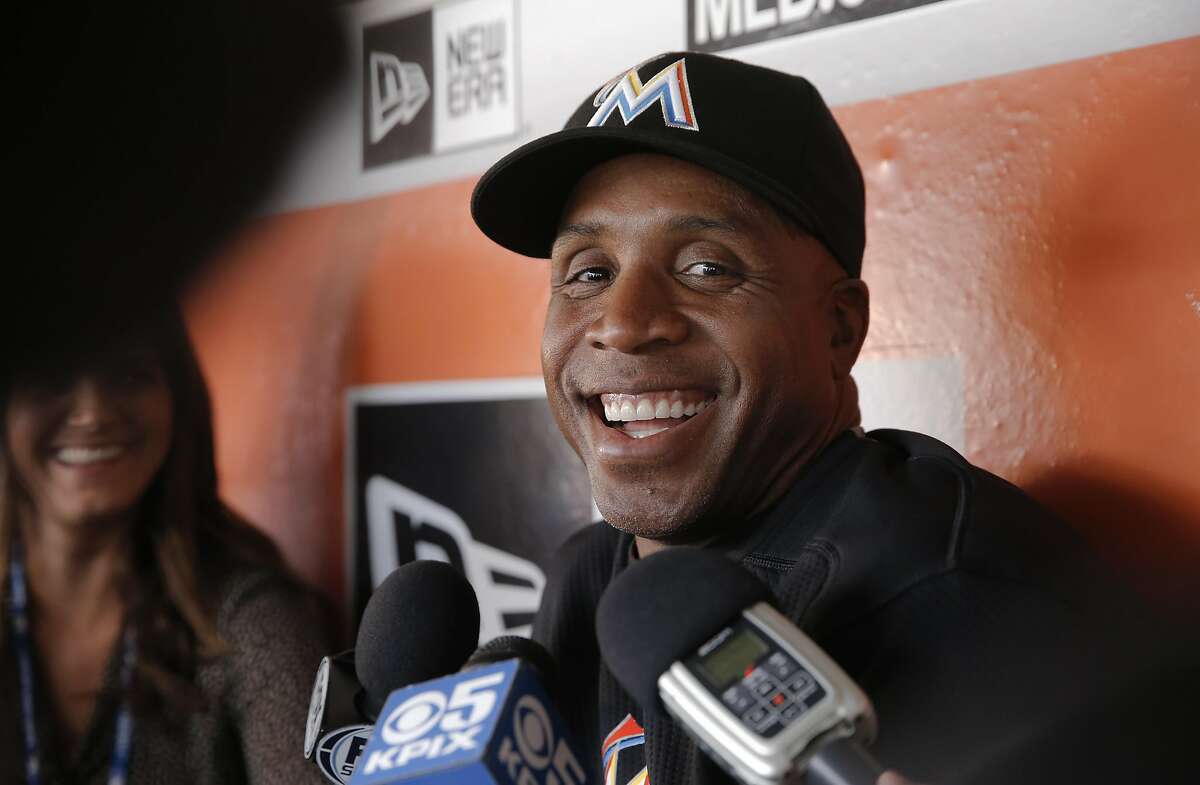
[191,38,1200,609]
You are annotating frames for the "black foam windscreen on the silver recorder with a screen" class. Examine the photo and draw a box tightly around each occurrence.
[596,547,772,708]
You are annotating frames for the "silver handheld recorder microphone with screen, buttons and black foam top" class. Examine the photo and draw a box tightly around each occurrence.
[596,547,883,785]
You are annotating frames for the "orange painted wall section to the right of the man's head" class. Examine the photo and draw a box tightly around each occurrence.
[839,33,1200,587]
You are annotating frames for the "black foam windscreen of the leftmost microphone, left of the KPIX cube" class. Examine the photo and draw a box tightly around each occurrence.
[354,561,479,706]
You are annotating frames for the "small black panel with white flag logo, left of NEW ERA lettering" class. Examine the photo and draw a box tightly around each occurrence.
[362,11,433,169]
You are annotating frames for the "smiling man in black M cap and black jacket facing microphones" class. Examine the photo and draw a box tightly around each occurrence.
[472,53,1113,785]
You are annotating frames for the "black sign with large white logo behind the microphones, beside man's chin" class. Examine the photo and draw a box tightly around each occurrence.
[347,382,593,640]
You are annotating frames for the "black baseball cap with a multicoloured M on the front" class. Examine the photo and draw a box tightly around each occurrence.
[470,52,866,277]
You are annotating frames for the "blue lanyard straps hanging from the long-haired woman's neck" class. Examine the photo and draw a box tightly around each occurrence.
[8,543,134,785]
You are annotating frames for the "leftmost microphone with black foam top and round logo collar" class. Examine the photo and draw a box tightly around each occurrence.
[304,561,479,785]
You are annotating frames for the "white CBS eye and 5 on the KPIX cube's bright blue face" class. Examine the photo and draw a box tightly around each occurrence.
[382,672,504,756]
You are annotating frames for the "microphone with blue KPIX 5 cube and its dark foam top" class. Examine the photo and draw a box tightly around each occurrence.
[349,636,587,785]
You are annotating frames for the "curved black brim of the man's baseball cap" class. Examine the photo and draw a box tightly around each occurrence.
[470,127,811,259]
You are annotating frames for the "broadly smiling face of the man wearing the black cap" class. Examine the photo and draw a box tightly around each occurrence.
[542,155,866,543]
